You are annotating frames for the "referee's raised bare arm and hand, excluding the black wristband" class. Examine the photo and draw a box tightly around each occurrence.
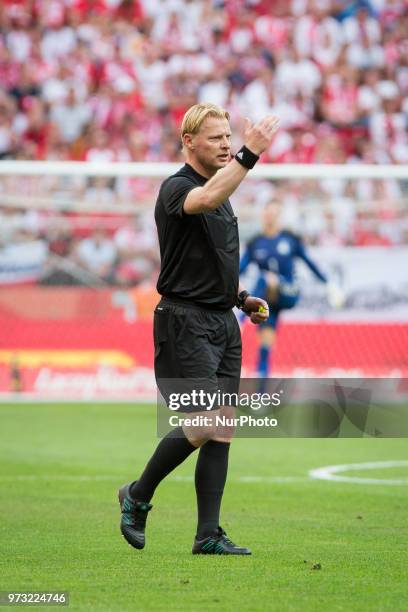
[184,116,279,215]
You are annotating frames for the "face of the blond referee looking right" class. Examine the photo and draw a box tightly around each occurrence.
[185,117,231,174]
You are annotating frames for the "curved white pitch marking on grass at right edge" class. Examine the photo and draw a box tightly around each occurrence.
[309,461,408,486]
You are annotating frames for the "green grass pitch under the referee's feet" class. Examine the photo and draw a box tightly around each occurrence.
[0,403,408,612]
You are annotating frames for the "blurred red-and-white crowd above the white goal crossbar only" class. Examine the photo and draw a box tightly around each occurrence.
[0,0,408,163]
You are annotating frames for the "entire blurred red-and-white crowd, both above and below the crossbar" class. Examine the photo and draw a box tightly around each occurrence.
[0,0,408,286]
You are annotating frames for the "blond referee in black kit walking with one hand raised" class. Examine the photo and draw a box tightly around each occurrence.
[119,104,278,555]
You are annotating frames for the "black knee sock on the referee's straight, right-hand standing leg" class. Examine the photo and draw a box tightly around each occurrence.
[195,440,230,540]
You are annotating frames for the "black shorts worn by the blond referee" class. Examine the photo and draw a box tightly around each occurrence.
[154,298,242,412]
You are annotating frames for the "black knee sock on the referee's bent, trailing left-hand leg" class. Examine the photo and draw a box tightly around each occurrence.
[130,427,196,502]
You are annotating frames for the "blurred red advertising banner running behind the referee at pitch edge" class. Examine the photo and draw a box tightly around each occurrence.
[0,287,408,401]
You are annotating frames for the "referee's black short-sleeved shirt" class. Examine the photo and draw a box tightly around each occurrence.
[155,164,239,310]
